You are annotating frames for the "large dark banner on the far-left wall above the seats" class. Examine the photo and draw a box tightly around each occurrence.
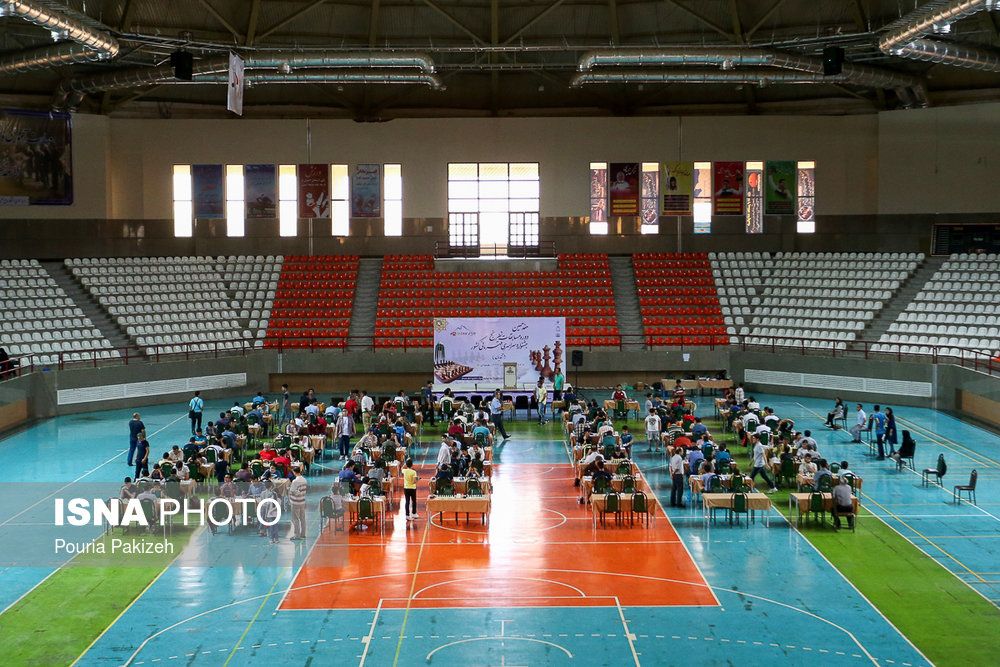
[0,109,73,206]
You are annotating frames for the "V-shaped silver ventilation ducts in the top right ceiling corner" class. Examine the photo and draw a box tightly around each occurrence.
[878,0,1000,72]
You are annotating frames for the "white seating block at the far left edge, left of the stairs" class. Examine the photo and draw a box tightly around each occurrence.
[0,259,119,365]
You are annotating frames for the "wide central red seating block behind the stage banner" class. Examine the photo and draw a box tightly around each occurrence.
[375,254,620,348]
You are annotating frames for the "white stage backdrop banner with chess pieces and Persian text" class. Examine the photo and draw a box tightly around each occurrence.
[434,317,566,392]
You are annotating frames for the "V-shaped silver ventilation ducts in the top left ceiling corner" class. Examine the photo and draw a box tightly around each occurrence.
[0,0,118,67]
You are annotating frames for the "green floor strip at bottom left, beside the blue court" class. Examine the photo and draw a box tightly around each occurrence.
[0,526,197,665]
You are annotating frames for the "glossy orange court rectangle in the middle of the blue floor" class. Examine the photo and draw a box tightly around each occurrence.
[281,463,718,609]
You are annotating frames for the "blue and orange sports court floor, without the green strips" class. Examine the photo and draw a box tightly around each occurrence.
[0,396,1000,667]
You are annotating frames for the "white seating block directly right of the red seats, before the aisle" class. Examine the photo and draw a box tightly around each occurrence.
[709,252,923,350]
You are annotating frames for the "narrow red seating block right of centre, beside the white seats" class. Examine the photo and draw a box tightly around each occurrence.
[632,253,729,347]
